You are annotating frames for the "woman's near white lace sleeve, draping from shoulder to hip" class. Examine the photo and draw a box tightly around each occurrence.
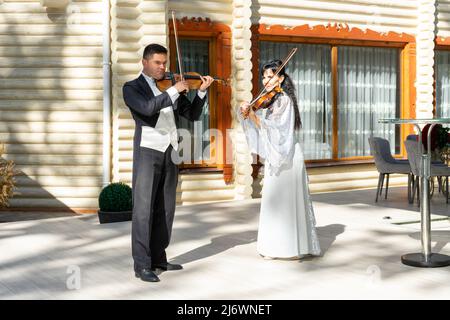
[260,94,295,173]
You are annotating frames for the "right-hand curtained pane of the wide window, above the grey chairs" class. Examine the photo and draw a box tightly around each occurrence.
[338,46,400,158]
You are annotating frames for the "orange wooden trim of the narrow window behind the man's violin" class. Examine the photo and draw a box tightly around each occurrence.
[169,17,233,183]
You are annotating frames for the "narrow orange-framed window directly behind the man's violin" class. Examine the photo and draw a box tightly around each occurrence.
[169,18,233,183]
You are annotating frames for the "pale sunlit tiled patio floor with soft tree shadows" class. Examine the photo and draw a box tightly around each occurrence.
[0,188,450,299]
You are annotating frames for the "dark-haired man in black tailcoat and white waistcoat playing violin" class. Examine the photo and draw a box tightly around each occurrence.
[123,44,214,282]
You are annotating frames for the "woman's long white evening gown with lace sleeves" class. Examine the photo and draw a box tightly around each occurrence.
[238,93,320,258]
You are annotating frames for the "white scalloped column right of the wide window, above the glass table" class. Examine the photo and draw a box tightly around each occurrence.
[416,0,436,119]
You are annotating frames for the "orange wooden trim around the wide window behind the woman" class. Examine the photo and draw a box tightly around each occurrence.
[251,24,416,164]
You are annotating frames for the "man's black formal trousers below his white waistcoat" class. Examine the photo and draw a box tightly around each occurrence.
[131,146,178,270]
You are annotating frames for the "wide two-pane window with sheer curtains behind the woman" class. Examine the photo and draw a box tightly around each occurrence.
[259,41,400,160]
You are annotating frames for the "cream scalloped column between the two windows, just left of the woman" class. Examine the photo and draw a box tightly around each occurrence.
[231,0,253,200]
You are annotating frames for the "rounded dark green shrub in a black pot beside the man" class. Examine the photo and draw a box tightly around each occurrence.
[98,182,133,223]
